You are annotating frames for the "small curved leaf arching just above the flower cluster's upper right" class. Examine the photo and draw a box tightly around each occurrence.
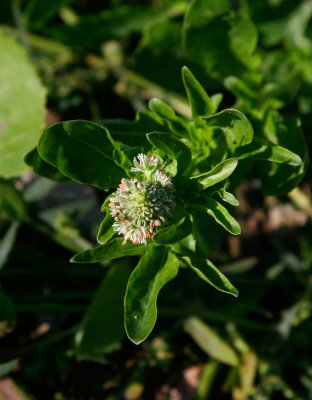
[147,132,192,174]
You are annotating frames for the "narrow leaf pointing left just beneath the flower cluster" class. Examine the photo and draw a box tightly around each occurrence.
[71,239,148,263]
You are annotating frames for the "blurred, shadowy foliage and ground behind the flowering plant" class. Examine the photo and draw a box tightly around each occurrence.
[0,0,312,400]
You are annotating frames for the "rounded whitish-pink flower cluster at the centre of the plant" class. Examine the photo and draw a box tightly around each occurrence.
[109,154,175,244]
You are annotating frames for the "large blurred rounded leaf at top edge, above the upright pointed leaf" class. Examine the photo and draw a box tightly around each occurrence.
[183,0,258,79]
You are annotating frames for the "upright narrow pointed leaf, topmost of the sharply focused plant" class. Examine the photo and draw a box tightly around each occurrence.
[182,67,214,119]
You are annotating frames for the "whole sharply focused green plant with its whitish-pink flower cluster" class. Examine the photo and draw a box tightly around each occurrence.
[26,67,305,343]
